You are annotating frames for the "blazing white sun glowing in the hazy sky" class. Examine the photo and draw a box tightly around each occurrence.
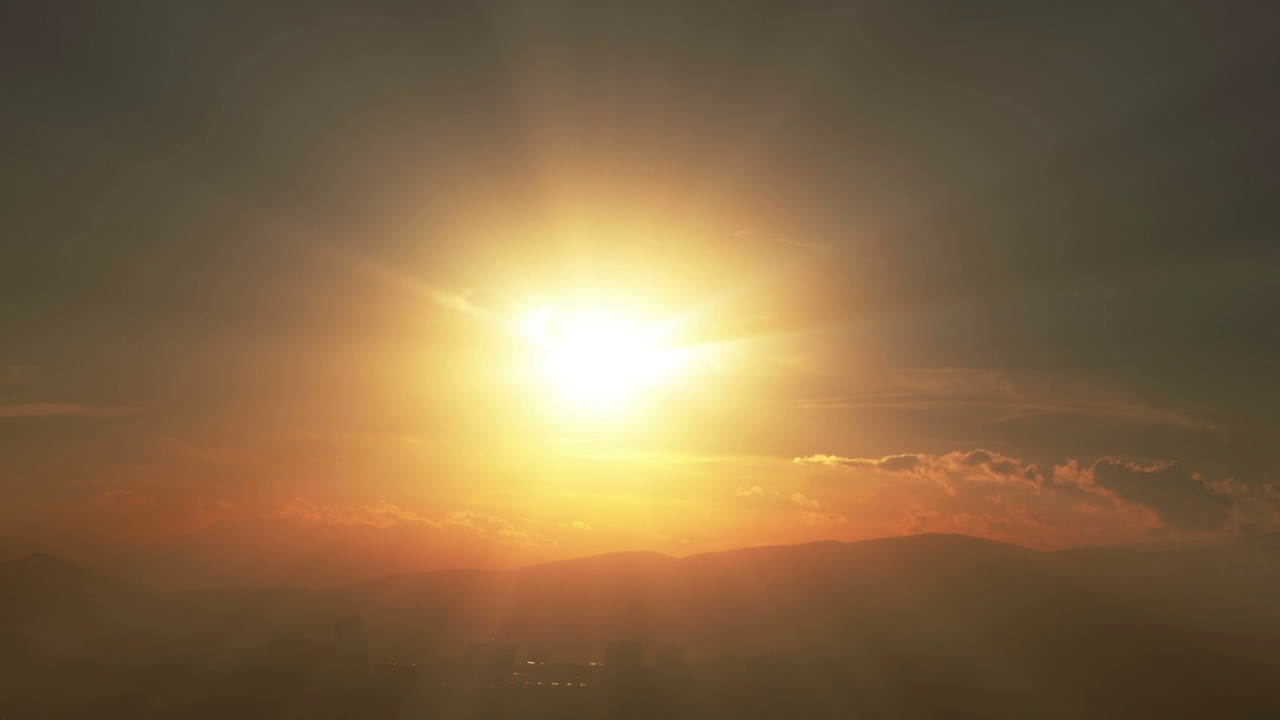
[522,307,686,413]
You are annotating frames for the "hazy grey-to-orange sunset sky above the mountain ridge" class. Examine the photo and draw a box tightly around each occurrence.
[0,0,1280,588]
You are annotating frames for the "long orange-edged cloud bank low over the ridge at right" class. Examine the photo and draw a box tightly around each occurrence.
[791,448,1254,547]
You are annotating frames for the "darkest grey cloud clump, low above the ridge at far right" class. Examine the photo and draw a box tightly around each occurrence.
[1088,457,1234,530]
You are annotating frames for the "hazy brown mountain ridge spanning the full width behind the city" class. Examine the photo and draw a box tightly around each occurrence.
[0,533,1280,661]
